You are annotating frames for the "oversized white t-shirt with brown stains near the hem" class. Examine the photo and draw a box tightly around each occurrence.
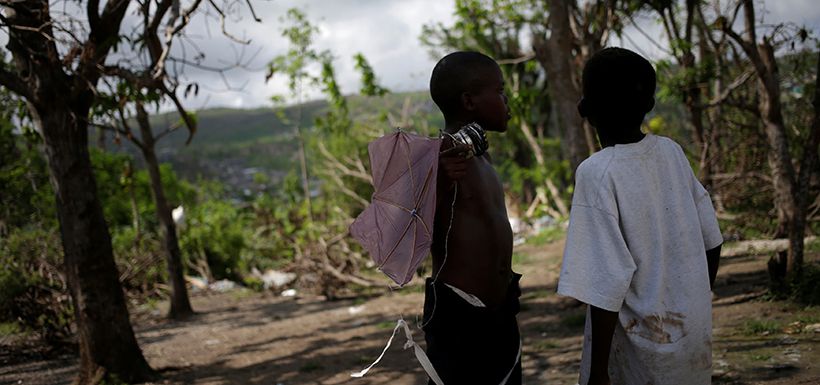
[558,135,723,385]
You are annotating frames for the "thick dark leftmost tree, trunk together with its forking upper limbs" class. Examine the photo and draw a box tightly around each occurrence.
[0,0,154,384]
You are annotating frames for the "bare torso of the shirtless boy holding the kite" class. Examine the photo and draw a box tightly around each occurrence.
[432,155,513,307]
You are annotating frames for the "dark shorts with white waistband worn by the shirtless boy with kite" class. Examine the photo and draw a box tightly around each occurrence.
[423,273,521,385]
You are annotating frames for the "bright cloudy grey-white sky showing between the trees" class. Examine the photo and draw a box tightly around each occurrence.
[0,0,820,109]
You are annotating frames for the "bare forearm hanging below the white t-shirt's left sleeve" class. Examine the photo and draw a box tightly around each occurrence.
[587,305,618,385]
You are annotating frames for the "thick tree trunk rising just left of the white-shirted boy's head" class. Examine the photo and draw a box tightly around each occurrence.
[533,0,594,174]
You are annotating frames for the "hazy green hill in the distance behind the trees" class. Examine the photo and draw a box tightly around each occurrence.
[114,92,441,192]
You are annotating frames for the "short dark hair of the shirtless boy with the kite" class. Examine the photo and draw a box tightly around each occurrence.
[430,51,498,115]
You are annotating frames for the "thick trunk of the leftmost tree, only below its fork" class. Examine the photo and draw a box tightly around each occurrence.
[31,100,154,384]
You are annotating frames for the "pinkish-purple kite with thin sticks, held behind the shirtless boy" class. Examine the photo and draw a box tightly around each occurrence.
[350,131,441,286]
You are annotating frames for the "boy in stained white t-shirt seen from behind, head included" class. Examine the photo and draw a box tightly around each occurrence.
[558,48,723,385]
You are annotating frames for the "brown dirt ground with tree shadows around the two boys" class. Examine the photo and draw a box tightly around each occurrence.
[0,238,820,385]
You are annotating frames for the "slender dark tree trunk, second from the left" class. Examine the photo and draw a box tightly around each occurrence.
[137,104,194,320]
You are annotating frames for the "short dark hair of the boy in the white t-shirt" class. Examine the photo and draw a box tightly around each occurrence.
[582,47,656,114]
